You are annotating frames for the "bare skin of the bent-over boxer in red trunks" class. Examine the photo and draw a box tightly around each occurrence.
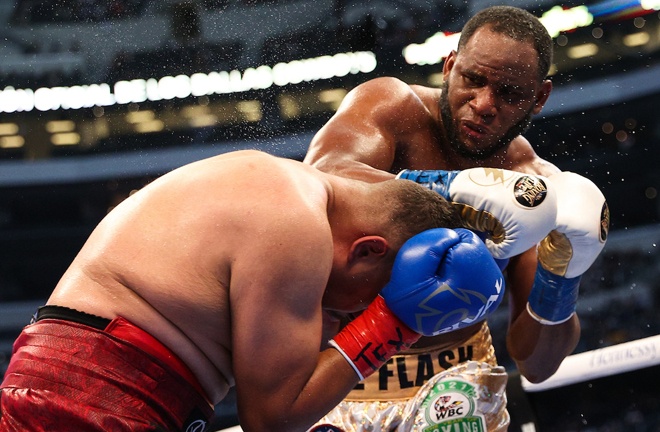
[48,151,402,430]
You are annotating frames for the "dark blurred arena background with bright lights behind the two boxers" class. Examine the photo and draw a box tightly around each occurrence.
[0,0,660,432]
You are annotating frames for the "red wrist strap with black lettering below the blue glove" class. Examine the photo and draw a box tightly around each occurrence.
[329,296,421,381]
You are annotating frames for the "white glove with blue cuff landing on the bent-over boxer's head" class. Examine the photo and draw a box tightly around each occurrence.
[397,168,557,260]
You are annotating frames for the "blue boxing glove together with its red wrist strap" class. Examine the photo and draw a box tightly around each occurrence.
[329,228,504,380]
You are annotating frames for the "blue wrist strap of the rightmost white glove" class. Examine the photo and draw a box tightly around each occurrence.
[527,263,581,325]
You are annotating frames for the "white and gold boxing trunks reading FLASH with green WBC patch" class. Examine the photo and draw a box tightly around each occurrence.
[309,323,510,432]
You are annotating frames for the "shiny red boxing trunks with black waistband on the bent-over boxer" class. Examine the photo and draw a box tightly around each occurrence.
[0,306,213,432]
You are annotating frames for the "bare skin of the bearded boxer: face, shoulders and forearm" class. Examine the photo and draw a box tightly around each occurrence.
[305,27,580,382]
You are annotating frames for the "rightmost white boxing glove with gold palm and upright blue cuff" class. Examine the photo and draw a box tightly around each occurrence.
[527,171,610,325]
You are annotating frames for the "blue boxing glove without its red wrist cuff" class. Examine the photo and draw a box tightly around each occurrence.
[381,228,504,336]
